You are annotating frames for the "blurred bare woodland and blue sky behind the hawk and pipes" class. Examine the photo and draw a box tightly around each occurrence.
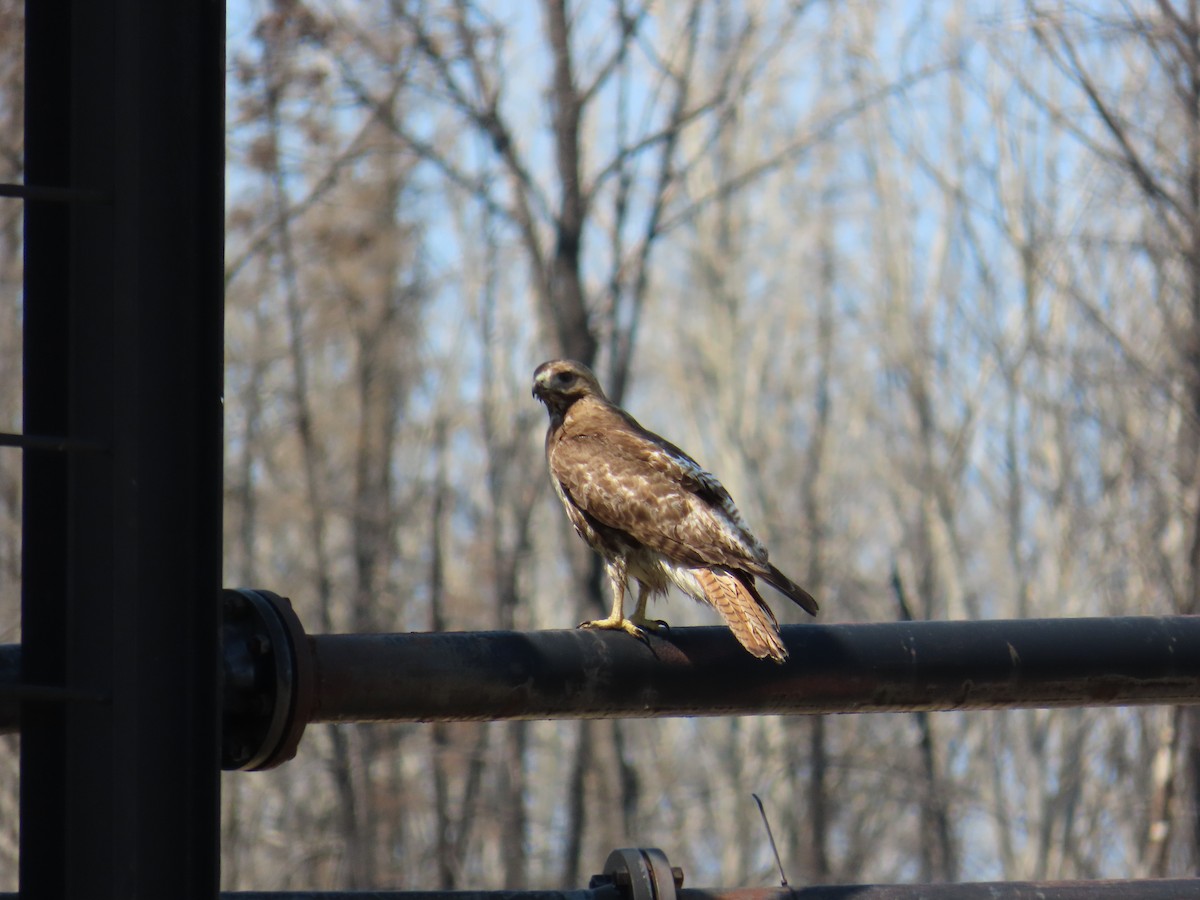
[0,0,1200,890]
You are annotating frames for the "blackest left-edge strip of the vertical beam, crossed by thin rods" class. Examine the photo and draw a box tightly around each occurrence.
[20,0,72,896]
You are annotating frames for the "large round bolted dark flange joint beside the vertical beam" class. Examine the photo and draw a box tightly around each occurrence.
[221,588,314,772]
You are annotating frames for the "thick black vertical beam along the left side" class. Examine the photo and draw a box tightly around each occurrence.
[20,0,224,898]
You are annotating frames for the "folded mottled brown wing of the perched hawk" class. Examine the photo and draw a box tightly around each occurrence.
[550,427,774,574]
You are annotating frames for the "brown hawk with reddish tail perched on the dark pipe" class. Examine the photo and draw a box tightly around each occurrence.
[533,360,817,662]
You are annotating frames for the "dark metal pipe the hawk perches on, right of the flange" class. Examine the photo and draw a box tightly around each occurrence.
[307,617,1200,722]
